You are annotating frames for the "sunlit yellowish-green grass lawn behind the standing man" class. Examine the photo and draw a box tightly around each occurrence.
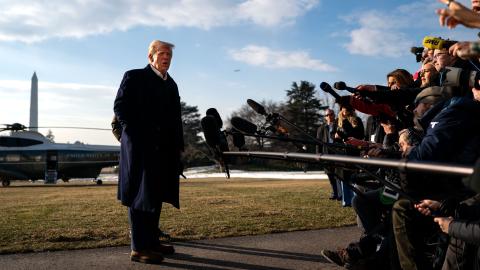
[0,178,355,253]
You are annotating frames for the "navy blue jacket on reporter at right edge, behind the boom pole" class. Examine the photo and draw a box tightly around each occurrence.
[403,97,480,198]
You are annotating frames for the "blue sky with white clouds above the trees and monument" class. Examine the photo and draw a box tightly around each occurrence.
[0,0,478,144]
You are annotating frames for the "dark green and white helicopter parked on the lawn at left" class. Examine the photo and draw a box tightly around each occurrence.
[0,123,120,187]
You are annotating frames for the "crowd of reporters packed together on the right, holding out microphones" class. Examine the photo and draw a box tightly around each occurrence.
[317,0,480,270]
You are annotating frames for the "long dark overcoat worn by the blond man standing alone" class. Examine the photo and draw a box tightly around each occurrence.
[114,65,184,212]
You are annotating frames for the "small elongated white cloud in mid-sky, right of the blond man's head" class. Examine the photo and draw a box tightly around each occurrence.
[230,45,336,71]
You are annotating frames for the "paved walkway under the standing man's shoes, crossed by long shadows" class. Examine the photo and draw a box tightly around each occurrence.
[0,227,360,270]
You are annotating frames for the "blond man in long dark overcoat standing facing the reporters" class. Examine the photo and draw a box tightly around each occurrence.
[114,40,184,263]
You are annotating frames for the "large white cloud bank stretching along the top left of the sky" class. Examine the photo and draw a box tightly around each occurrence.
[0,0,319,43]
